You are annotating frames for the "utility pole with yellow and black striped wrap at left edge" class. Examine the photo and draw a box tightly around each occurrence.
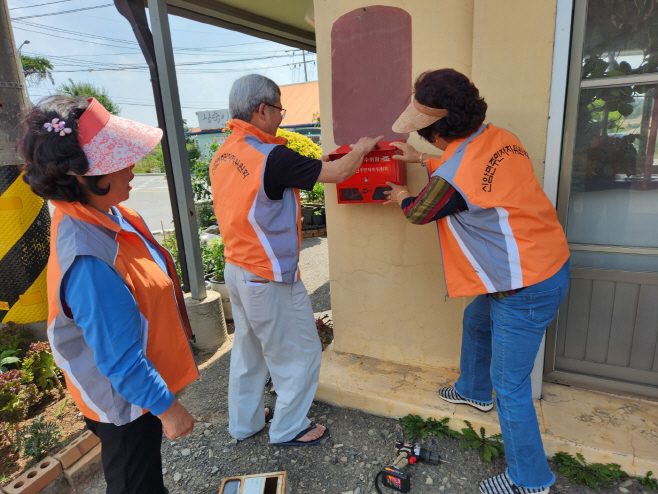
[0,0,50,324]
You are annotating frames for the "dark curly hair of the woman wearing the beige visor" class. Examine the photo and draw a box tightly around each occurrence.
[414,69,487,142]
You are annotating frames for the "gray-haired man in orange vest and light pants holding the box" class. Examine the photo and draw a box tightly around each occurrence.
[210,74,381,446]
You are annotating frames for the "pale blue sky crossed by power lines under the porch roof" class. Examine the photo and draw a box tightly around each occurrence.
[8,0,317,127]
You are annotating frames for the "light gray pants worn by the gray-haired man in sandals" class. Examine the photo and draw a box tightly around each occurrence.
[224,263,322,443]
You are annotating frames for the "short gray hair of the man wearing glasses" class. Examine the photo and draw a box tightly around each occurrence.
[228,74,281,122]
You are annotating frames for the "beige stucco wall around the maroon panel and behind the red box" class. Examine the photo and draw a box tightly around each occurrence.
[315,0,555,368]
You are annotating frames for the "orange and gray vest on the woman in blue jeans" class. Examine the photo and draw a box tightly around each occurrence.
[428,124,569,297]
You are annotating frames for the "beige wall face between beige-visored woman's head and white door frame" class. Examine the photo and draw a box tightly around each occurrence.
[471,0,566,183]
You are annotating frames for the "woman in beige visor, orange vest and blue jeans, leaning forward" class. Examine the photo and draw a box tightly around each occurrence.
[387,69,569,494]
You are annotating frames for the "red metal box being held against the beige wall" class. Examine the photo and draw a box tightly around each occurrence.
[329,141,407,204]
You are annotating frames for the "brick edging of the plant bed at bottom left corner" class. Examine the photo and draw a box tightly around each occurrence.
[0,431,101,494]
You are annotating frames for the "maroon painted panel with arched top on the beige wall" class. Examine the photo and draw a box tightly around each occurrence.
[331,5,412,145]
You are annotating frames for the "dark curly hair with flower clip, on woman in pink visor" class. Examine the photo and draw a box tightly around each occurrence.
[16,95,110,204]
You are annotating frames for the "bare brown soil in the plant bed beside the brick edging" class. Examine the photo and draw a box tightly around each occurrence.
[0,389,85,483]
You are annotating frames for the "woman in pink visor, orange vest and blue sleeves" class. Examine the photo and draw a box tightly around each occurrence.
[18,96,198,494]
